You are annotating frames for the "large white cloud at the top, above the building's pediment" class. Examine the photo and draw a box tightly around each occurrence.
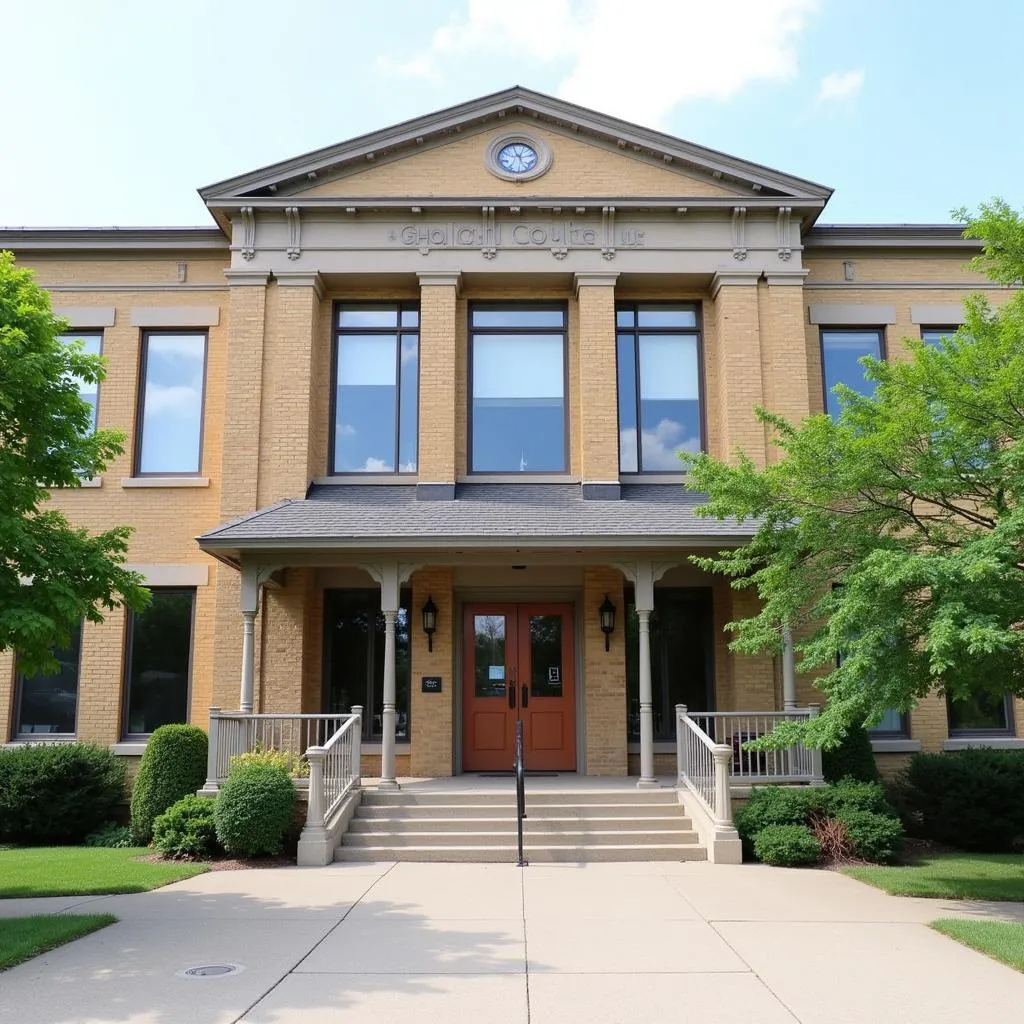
[388,0,818,124]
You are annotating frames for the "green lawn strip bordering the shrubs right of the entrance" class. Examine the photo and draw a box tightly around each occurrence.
[839,853,1024,900]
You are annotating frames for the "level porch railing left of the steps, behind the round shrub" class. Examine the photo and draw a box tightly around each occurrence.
[204,708,355,793]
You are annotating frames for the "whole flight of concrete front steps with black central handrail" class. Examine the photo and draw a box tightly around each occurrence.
[335,785,707,863]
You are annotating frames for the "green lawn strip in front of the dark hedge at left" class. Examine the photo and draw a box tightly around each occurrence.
[0,846,208,899]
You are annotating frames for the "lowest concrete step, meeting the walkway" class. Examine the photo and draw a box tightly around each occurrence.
[334,843,708,864]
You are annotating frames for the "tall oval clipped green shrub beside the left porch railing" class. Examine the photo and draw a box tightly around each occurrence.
[131,725,208,846]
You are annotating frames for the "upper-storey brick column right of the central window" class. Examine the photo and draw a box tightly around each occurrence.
[571,271,620,499]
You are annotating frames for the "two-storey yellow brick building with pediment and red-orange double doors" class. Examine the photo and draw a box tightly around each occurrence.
[0,88,1024,782]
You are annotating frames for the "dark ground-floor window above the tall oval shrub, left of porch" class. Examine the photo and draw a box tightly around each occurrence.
[125,589,196,736]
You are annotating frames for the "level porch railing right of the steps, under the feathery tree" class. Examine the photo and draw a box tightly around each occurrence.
[680,705,822,785]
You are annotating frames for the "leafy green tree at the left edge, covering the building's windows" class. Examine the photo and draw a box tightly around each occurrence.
[0,252,148,673]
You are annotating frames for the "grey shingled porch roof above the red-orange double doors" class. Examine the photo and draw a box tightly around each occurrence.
[199,483,755,558]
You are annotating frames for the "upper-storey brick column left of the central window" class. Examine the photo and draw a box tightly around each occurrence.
[416,270,460,499]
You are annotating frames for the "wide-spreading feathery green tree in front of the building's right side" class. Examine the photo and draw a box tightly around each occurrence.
[686,200,1024,746]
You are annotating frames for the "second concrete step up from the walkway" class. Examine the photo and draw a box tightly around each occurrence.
[349,812,692,834]
